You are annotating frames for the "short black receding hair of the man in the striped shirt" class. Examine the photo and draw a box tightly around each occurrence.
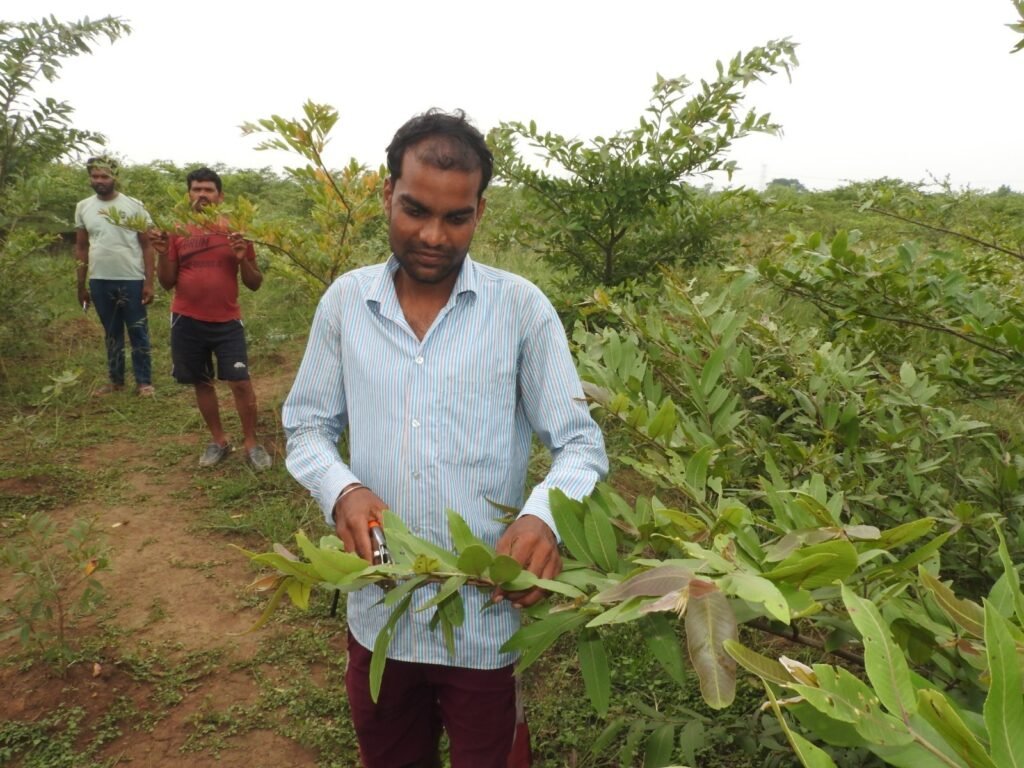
[387,108,495,197]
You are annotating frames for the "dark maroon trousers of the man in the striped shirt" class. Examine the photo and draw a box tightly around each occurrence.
[345,634,529,768]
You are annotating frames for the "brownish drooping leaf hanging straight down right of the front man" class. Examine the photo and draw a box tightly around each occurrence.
[685,580,736,710]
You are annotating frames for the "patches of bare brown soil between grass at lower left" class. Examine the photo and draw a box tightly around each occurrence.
[0,362,325,768]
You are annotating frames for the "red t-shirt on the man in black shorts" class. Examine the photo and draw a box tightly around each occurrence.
[167,229,256,323]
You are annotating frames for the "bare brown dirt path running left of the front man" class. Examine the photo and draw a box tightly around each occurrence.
[0,356,341,768]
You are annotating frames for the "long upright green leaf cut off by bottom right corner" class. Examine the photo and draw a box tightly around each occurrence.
[984,602,1024,768]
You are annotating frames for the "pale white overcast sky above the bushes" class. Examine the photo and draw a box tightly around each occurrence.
[8,0,1024,191]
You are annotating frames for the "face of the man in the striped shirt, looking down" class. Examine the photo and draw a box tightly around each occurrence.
[384,146,486,285]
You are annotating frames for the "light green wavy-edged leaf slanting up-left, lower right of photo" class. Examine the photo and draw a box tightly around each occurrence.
[842,586,918,722]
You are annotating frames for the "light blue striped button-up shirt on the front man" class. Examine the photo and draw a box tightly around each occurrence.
[283,256,607,669]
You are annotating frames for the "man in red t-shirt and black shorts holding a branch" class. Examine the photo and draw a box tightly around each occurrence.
[150,168,271,471]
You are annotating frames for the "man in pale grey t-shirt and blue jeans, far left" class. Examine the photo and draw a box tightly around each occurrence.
[75,158,155,396]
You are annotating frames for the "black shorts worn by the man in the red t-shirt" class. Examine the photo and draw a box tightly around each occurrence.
[171,313,249,384]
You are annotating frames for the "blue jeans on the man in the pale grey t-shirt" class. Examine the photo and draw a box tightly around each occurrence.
[89,280,153,386]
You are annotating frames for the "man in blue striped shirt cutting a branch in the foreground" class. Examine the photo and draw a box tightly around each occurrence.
[283,111,607,768]
